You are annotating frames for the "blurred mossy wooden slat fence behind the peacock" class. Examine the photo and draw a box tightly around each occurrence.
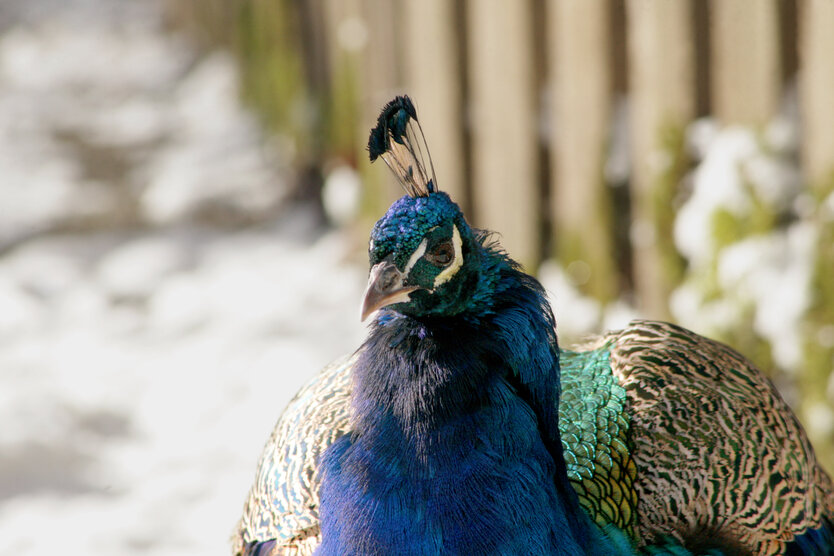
[167,0,834,317]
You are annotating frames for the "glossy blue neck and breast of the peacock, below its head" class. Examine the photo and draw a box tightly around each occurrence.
[318,249,610,554]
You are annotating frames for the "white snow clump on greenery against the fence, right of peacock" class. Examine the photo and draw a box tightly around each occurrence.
[670,103,817,372]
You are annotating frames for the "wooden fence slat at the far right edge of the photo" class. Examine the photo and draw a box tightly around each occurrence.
[799,0,834,472]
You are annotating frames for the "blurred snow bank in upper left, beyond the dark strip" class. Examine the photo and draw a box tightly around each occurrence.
[0,0,286,241]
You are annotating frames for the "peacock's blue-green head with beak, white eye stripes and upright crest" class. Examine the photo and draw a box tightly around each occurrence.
[361,97,481,320]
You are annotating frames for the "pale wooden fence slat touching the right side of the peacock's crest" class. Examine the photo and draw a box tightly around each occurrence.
[403,0,469,212]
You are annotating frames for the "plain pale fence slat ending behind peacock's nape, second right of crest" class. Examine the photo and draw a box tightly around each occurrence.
[467,0,541,269]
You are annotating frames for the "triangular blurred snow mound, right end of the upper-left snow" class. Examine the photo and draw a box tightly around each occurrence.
[140,53,282,223]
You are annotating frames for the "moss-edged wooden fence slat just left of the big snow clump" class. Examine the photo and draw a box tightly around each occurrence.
[626,0,695,318]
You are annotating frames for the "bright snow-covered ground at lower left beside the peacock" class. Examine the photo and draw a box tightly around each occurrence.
[0,228,365,554]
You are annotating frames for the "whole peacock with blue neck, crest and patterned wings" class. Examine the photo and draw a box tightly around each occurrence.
[233,96,834,556]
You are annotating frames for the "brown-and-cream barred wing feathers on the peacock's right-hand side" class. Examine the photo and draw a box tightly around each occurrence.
[601,321,834,556]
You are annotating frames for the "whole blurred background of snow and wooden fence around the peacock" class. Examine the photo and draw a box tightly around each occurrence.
[0,0,834,555]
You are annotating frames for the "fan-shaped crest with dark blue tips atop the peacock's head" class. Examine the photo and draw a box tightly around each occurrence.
[368,96,438,197]
